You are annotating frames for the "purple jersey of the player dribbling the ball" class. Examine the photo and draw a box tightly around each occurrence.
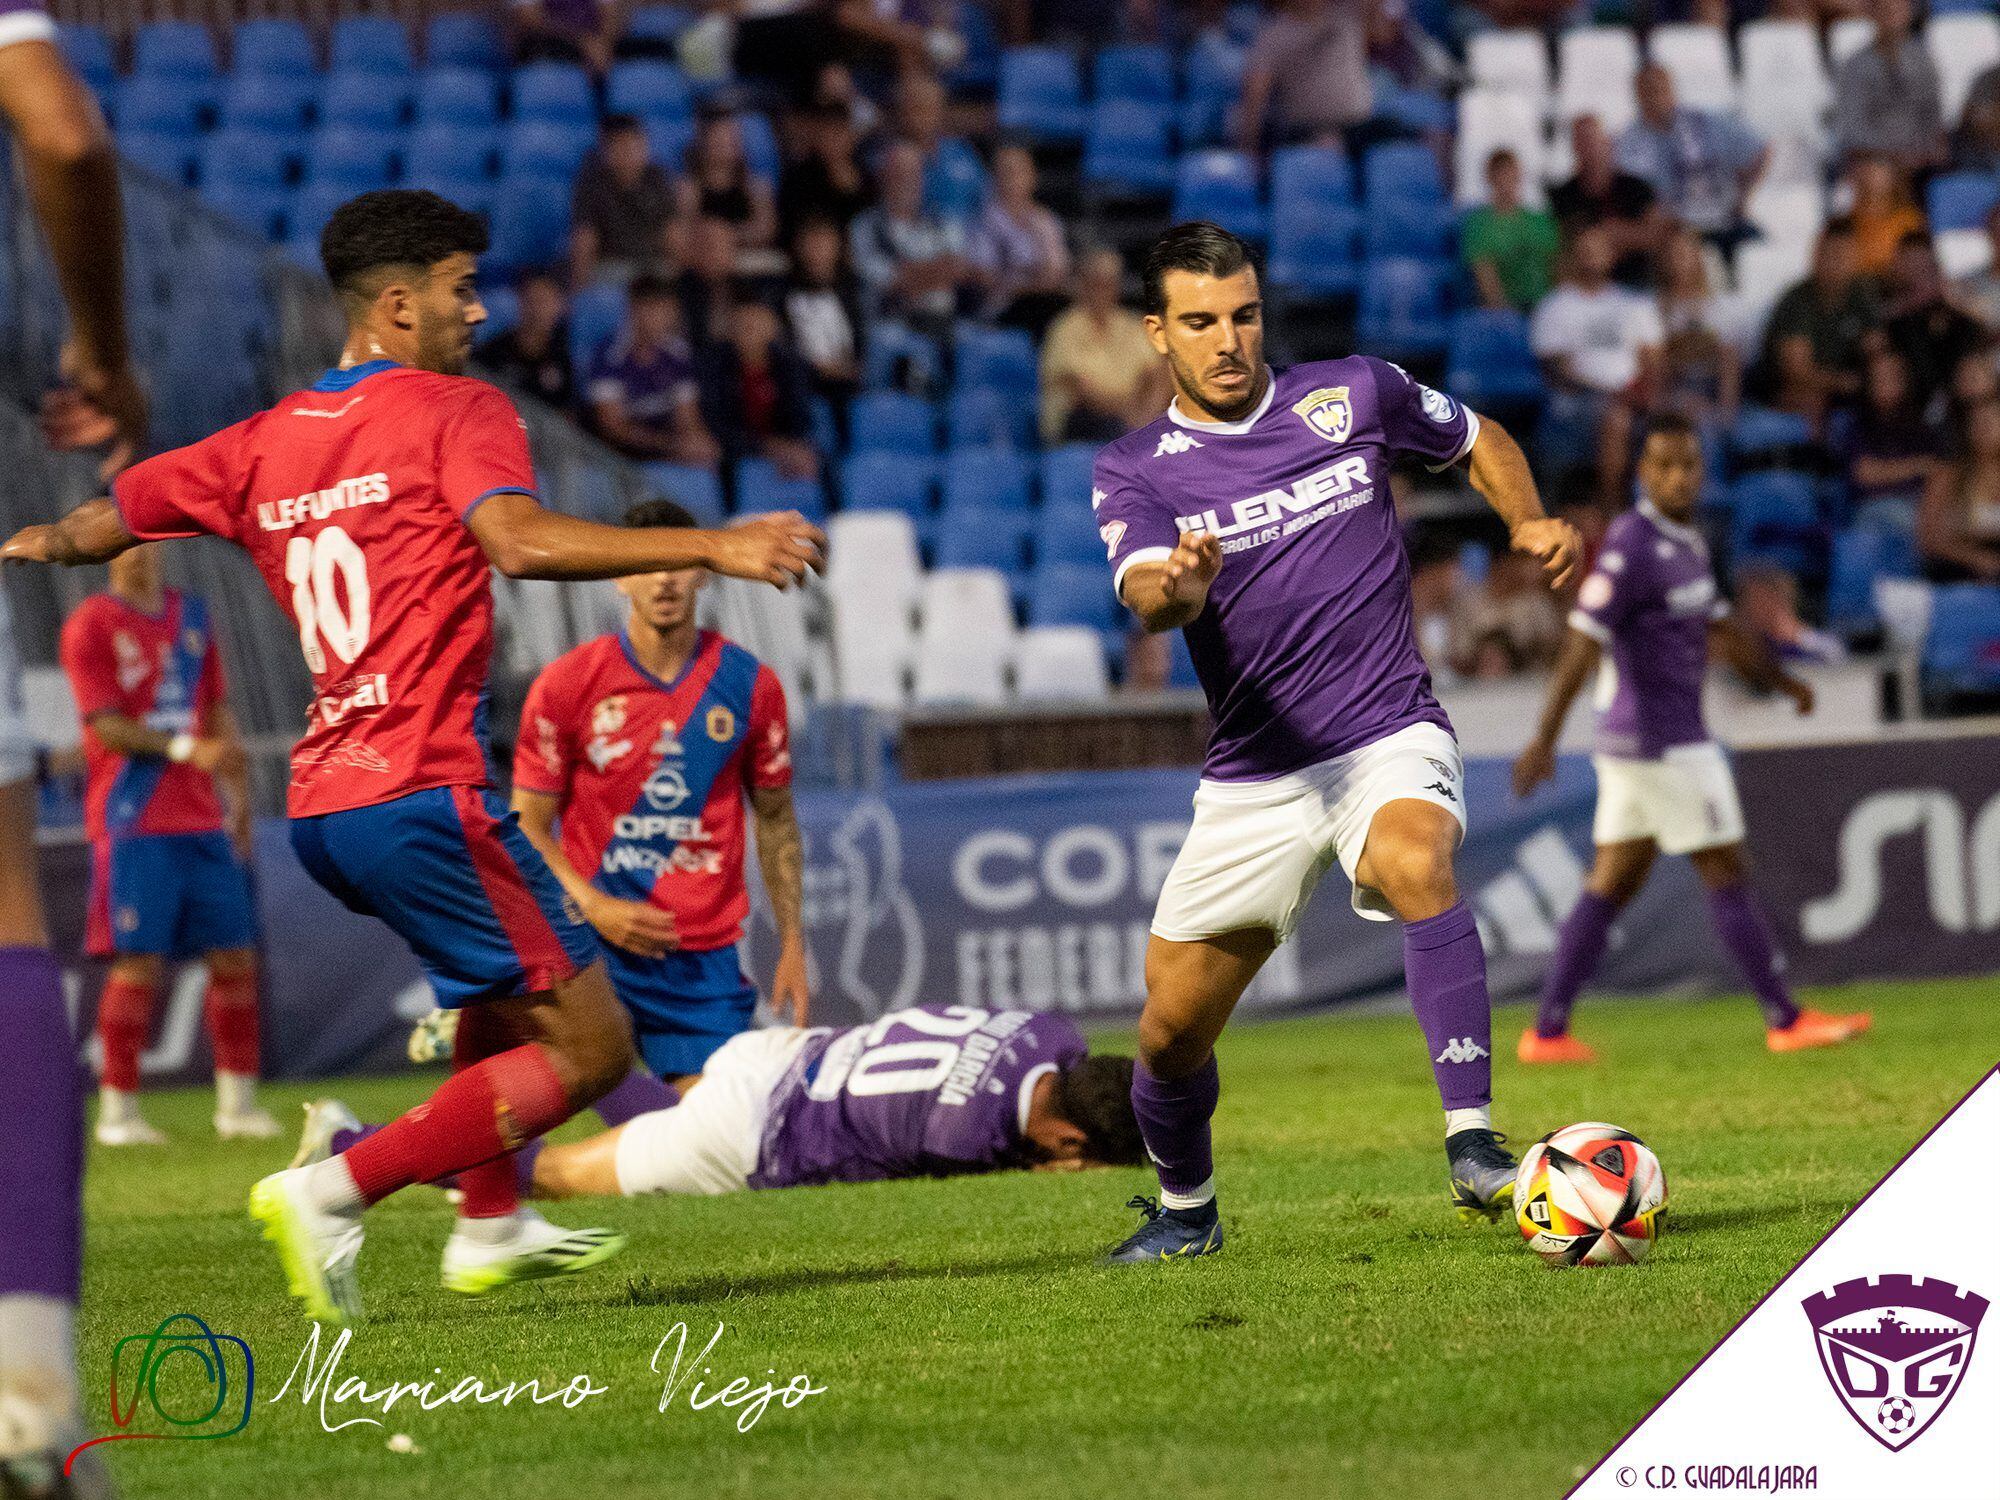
[1090,354,1480,782]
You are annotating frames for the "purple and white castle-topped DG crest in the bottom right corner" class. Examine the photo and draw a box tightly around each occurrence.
[1802,1276,1988,1450]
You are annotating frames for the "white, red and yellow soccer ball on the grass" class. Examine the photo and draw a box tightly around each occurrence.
[1514,1120,1666,1266]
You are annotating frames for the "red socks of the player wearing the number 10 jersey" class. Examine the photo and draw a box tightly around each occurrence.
[340,1042,570,1214]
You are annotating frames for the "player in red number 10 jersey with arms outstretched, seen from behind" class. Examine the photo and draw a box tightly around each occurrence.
[0,192,824,1322]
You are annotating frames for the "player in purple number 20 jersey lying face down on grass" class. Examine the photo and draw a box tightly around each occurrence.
[302,1006,1142,1198]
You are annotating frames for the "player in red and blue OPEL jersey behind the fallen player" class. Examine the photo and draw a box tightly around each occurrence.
[514,500,808,1082]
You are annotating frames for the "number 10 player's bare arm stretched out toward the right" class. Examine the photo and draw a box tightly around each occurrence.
[466,490,826,588]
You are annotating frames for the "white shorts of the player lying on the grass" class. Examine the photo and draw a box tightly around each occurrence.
[618,1026,812,1198]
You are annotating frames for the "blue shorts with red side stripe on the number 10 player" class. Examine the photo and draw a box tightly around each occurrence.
[292,786,598,1008]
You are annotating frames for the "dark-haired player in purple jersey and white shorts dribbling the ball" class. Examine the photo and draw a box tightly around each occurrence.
[1092,224,1580,1260]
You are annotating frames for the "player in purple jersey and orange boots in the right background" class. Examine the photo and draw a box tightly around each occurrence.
[1514,418,1870,1062]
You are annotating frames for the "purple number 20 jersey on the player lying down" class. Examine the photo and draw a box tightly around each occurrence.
[750,1006,1090,1188]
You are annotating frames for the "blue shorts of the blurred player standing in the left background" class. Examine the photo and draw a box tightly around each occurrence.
[86,834,256,958]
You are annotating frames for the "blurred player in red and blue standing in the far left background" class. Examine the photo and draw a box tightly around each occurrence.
[62,546,278,1146]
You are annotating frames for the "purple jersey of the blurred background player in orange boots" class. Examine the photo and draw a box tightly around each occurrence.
[1570,500,1730,760]
